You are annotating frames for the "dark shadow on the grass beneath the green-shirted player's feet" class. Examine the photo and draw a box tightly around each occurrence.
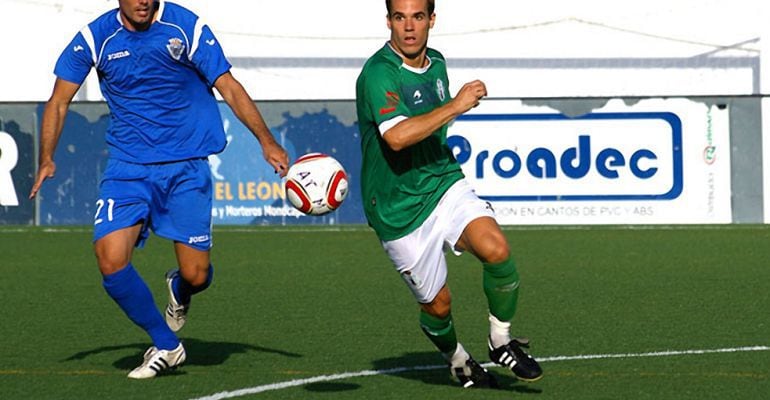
[373,352,542,394]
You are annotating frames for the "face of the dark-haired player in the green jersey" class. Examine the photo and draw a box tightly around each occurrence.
[388,0,436,68]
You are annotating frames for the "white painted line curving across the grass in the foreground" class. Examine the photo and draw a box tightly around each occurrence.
[191,346,770,400]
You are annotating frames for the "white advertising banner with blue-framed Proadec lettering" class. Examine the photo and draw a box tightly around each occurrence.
[449,99,731,225]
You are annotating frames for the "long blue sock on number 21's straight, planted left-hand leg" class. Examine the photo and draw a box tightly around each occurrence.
[102,263,179,350]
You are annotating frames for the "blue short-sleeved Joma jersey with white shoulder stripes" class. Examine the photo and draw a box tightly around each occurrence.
[54,0,231,164]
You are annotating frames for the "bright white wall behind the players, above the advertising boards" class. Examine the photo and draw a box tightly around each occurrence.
[0,0,766,101]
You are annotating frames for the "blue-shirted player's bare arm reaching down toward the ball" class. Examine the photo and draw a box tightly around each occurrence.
[214,71,289,177]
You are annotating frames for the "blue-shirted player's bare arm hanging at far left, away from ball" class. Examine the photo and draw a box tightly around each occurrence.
[29,78,80,199]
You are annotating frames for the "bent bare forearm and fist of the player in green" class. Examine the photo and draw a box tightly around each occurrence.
[382,80,487,151]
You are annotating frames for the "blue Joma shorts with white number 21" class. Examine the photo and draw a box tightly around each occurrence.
[94,158,211,251]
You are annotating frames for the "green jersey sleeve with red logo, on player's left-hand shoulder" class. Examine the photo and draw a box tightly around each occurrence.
[363,63,411,126]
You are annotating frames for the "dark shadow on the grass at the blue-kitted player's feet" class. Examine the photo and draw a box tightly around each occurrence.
[64,338,302,370]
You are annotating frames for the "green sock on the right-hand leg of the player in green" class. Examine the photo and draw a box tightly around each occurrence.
[483,257,519,321]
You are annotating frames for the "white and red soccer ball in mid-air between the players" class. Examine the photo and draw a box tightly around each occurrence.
[285,153,348,215]
